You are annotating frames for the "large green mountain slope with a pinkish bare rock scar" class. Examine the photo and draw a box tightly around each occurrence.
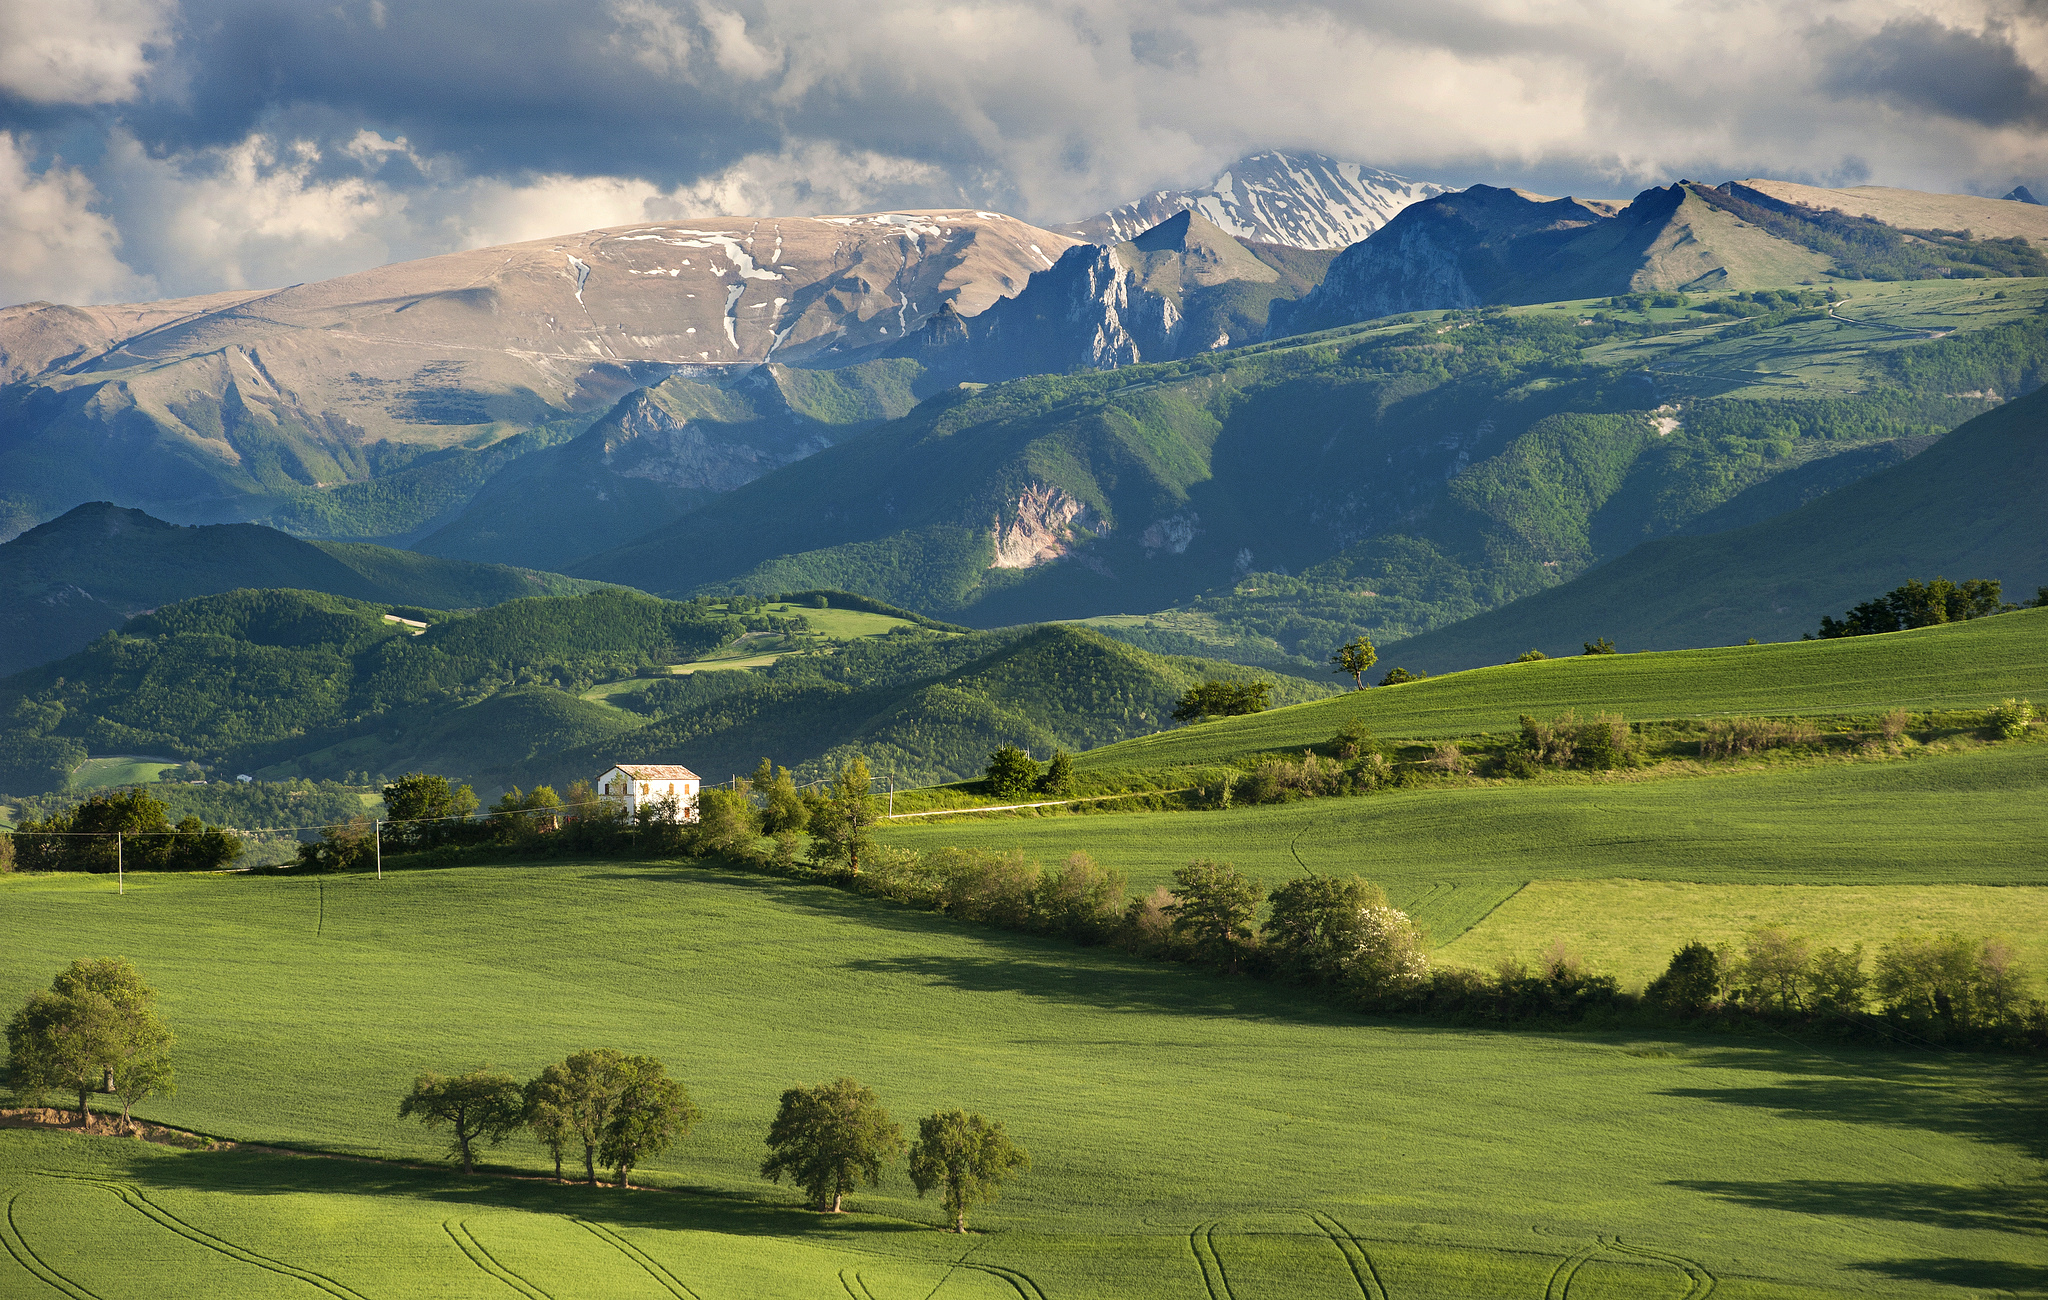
[571,280,2048,663]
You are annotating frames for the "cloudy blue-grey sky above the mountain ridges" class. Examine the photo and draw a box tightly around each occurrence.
[0,0,2048,303]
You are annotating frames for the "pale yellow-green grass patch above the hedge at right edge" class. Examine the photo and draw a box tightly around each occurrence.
[1438,880,2048,995]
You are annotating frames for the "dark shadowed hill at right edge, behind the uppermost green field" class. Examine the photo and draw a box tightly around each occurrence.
[1384,391,2048,671]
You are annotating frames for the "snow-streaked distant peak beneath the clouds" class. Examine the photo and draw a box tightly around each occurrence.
[1053,149,1448,248]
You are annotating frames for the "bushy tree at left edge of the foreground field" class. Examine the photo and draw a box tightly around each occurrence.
[6,956,172,1126]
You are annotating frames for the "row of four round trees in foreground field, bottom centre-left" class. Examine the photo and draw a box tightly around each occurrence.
[397,1048,1030,1232]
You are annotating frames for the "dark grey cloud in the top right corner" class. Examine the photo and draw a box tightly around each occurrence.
[1823,18,2048,127]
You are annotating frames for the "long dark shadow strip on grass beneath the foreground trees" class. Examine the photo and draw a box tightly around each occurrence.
[117,1149,936,1241]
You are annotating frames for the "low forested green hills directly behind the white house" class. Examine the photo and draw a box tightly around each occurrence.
[0,590,1335,794]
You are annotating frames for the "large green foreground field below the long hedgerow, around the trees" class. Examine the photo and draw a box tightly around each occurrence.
[0,859,2048,1300]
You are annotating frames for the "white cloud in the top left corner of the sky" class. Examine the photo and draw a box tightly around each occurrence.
[0,0,178,104]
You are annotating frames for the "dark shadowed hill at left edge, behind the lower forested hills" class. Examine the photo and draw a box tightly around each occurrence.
[0,502,600,676]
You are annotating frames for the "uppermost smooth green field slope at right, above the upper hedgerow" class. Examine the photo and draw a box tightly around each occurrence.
[1075,610,2048,768]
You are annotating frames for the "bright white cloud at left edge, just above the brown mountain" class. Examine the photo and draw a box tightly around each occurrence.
[0,131,156,303]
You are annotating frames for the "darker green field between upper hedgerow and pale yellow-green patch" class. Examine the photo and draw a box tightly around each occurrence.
[887,737,2048,929]
